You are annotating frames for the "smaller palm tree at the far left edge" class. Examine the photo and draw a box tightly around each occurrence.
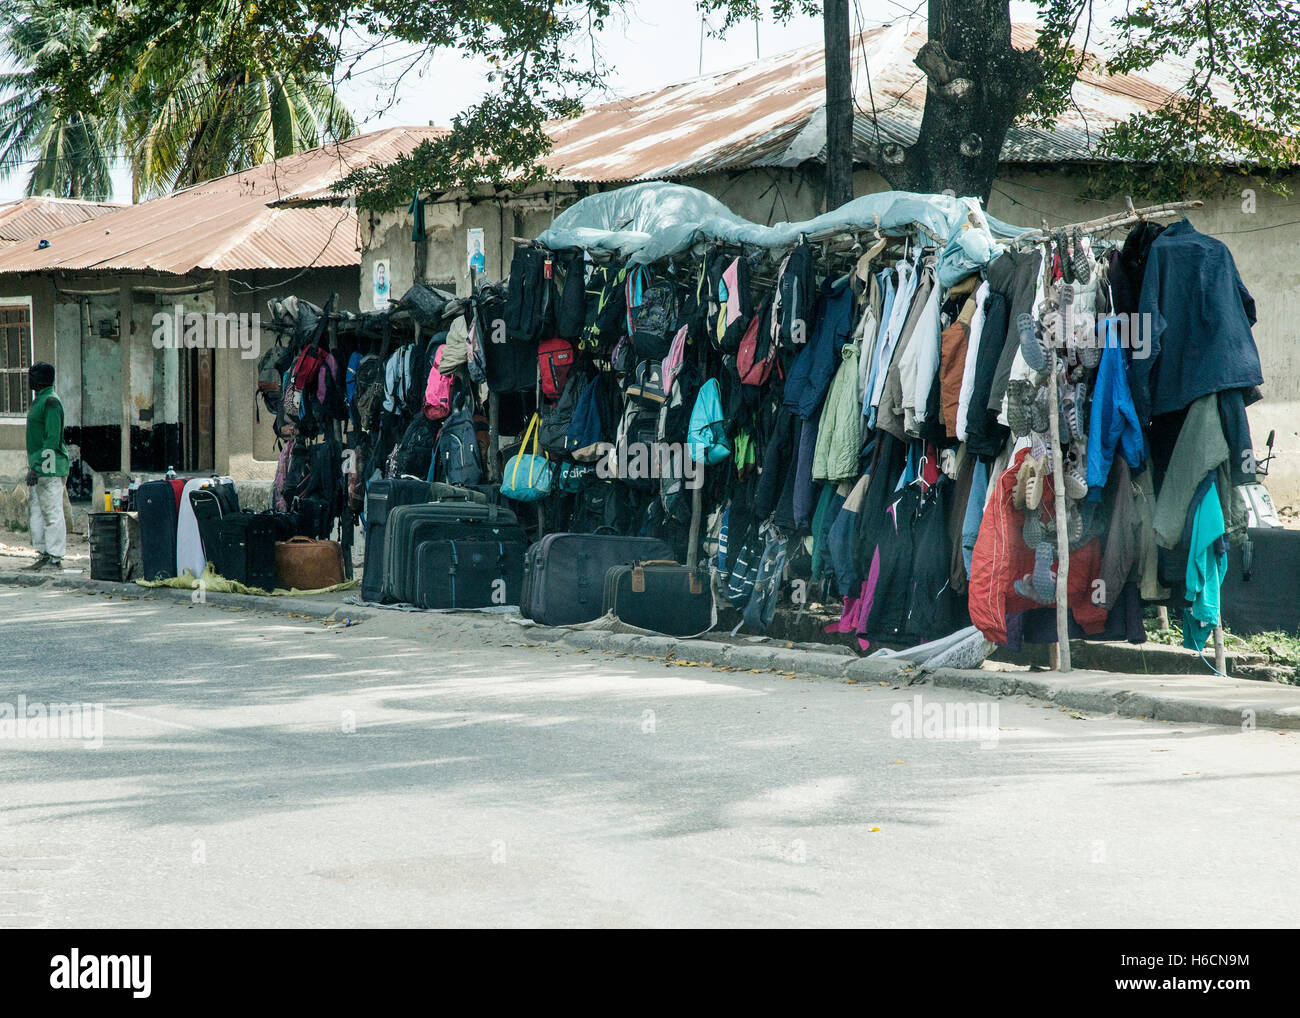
[0,4,116,202]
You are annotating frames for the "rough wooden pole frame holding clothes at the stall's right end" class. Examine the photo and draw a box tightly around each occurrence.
[1015,196,1206,673]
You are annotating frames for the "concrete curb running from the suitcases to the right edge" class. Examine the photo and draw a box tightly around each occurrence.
[530,627,1300,731]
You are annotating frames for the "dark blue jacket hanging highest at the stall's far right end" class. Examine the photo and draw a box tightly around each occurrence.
[1130,220,1264,424]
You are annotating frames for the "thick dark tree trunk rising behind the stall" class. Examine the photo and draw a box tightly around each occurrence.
[878,0,1043,203]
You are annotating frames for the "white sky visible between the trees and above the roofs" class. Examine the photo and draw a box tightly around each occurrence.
[0,0,1036,202]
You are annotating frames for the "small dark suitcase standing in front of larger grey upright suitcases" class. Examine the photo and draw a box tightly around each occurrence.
[412,540,528,608]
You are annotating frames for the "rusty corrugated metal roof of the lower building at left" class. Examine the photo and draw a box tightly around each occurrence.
[0,127,445,276]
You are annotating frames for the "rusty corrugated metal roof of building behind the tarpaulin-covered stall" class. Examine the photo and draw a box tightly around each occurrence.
[546,17,1232,182]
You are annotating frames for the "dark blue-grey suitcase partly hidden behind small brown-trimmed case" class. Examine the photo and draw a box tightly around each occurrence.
[519,533,672,625]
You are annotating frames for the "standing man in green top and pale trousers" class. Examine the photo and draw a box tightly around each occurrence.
[27,361,68,572]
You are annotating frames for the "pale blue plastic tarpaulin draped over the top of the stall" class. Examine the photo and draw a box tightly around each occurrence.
[537,181,1030,286]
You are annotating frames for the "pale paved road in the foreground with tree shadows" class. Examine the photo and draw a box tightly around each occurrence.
[0,588,1300,927]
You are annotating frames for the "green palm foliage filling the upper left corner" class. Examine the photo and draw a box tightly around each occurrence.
[0,0,356,199]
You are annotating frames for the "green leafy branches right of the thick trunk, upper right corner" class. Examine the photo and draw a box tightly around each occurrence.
[1022,0,1300,200]
